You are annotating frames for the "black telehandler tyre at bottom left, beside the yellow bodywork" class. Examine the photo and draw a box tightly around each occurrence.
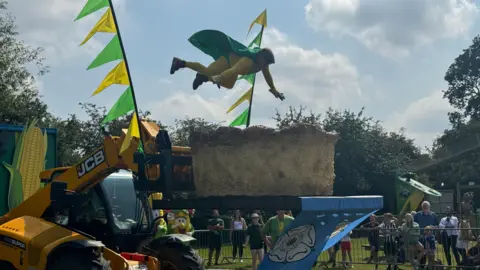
[47,249,112,270]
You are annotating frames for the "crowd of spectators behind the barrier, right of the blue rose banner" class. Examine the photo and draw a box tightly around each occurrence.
[350,201,480,269]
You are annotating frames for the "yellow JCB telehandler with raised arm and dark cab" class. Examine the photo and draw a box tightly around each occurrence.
[0,122,204,270]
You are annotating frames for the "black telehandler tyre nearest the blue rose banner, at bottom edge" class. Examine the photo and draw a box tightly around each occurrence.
[151,243,205,270]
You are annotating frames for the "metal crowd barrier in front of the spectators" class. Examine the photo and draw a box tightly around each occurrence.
[192,228,480,269]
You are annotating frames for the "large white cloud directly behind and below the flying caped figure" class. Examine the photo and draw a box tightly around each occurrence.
[149,27,361,125]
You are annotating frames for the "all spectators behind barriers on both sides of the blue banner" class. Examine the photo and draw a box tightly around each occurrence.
[202,201,480,270]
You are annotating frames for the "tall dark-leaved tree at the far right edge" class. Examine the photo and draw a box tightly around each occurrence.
[425,36,480,187]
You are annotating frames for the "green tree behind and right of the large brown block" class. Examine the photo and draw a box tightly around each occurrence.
[274,107,421,209]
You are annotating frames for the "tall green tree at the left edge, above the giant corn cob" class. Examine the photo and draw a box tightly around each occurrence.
[0,0,51,125]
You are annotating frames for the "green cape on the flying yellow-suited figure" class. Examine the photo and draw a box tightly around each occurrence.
[188,30,261,61]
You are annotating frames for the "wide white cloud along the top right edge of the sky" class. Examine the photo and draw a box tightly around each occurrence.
[305,0,478,58]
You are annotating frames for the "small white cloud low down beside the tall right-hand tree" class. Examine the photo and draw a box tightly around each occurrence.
[385,90,453,147]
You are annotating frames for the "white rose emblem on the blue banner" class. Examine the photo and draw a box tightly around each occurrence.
[268,225,315,263]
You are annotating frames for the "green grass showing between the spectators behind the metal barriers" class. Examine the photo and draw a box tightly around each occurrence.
[197,238,455,270]
